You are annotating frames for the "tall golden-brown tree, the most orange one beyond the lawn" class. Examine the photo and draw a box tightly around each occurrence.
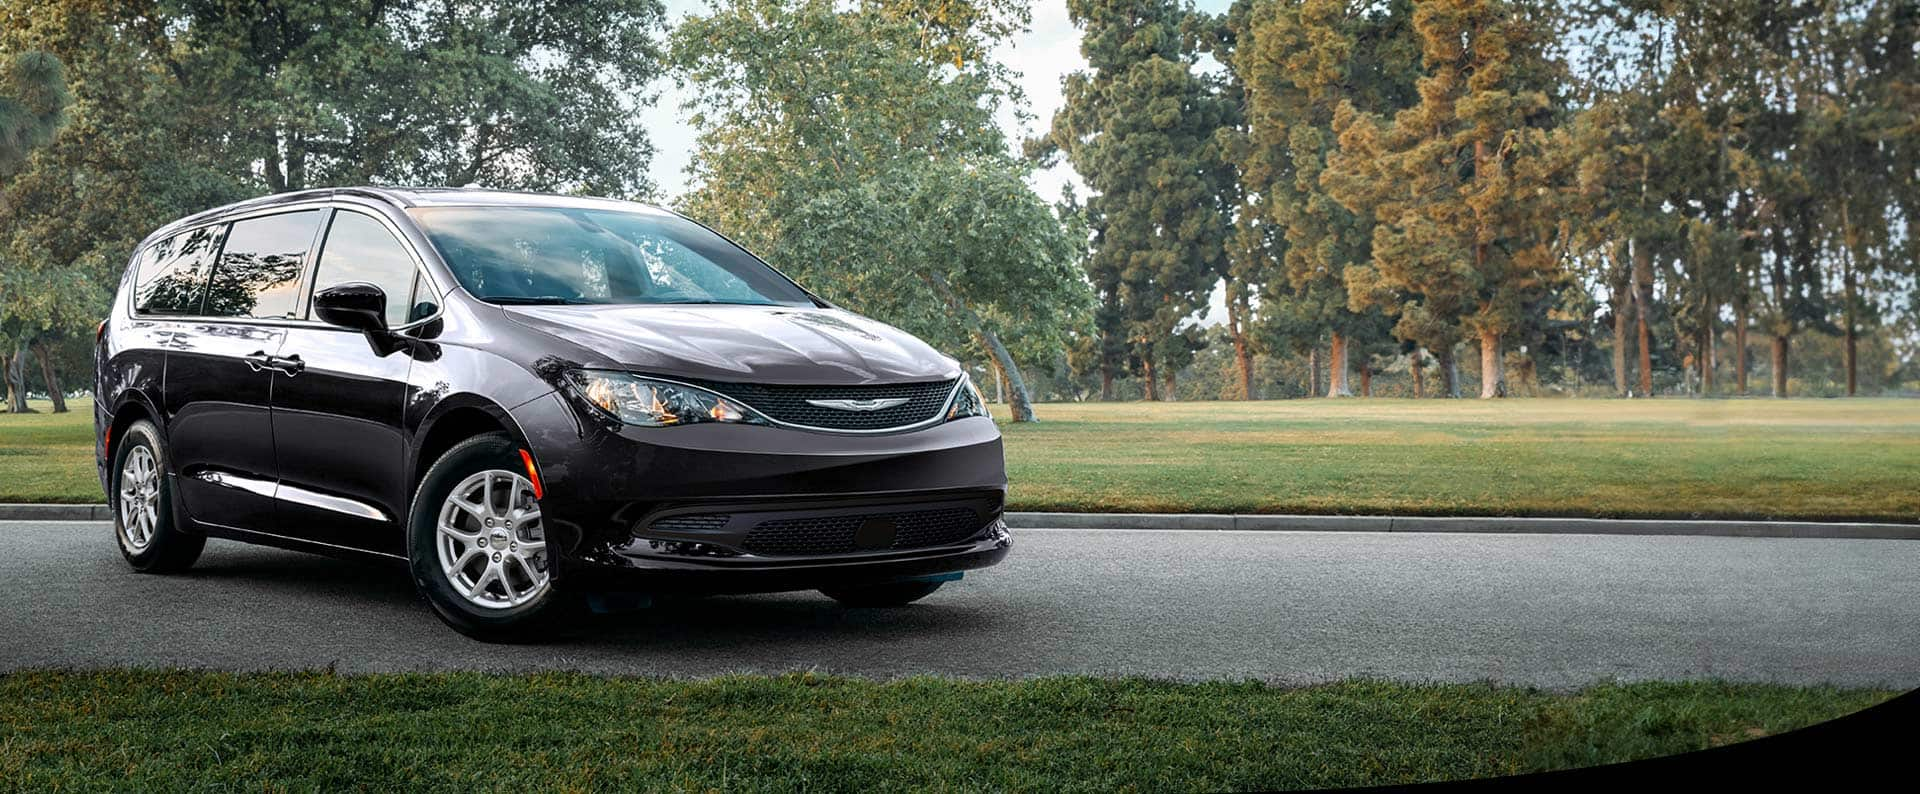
[1323,0,1569,397]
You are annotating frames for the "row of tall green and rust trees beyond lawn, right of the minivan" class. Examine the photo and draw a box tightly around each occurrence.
[1029,0,1920,399]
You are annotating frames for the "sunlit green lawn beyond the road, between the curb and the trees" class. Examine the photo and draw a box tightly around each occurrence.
[0,399,1920,522]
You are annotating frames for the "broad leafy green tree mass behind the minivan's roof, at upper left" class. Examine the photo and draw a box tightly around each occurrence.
[0,0,662,416]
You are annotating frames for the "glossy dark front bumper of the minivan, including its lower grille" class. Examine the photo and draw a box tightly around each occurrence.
[513,393,1012,593]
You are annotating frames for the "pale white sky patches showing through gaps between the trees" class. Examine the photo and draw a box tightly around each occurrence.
[647,0,1231,203]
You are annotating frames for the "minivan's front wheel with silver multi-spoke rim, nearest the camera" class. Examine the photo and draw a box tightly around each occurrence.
[407,433,578,642]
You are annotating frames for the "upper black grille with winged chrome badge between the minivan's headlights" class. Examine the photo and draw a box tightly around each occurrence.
[689,380,954,430]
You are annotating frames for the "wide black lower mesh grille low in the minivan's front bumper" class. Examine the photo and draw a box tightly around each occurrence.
[741,508,983,556]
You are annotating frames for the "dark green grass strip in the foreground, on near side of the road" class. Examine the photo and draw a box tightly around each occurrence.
[0,671,1893,790]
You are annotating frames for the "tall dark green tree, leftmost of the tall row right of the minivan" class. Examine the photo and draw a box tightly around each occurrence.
[1027,0,1233,399]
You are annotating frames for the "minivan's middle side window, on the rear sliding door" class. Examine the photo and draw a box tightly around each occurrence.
[205,209,323,318]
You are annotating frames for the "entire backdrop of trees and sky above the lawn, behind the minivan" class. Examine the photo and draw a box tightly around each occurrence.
[0,0,1920,418]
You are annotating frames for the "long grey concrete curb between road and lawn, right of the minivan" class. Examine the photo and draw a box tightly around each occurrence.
[1006,512,1920,541]
